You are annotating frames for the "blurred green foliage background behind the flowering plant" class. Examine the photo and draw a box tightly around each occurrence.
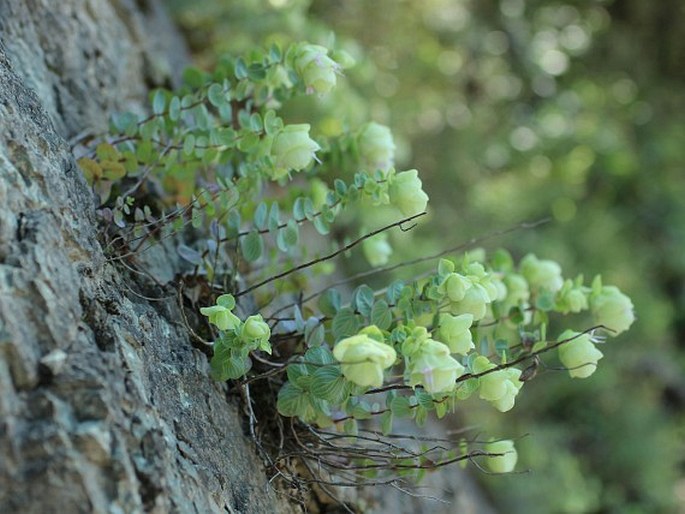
[170,0,685,513]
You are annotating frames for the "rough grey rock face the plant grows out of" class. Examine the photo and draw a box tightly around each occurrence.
[0,0,294,514]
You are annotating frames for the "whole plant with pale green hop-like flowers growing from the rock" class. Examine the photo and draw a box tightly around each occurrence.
[79,43,634,500]
